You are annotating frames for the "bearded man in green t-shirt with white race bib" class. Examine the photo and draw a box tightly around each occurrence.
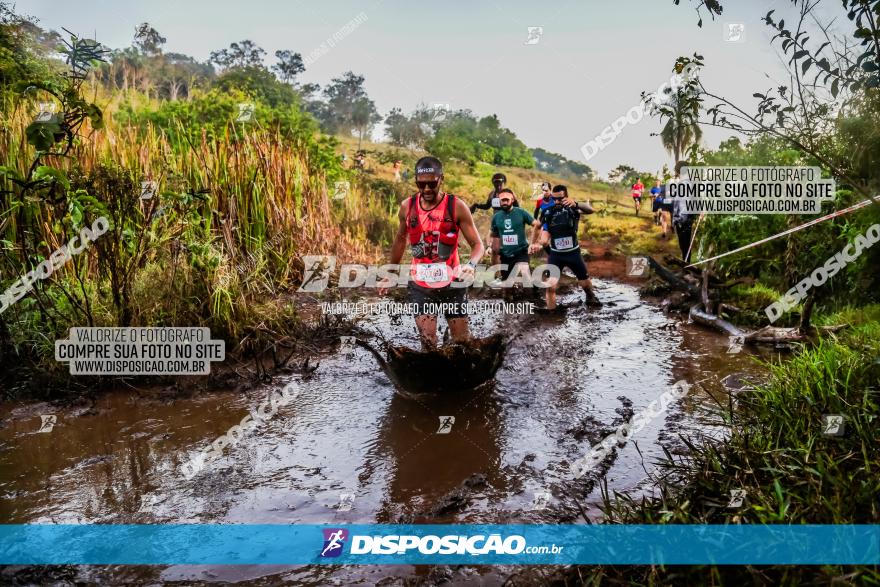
[491,188,541,286]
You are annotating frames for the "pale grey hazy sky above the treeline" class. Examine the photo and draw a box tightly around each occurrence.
[16,0,812,175]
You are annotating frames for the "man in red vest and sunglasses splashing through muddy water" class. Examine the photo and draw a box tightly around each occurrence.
[379,157,483,350]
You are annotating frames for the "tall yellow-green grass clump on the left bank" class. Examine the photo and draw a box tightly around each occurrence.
[0,85,397,392]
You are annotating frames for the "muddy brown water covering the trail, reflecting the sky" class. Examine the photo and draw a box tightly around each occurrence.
[0,280,780,585]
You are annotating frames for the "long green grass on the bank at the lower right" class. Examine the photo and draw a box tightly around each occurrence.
[581,306,880,585]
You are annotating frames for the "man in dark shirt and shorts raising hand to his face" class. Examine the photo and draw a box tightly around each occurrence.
[541,185,602,310]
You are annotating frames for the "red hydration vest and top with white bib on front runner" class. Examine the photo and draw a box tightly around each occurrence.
[406,194,459,288]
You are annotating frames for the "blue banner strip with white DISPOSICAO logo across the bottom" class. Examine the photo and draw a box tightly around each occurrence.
[0,524,880,565]
